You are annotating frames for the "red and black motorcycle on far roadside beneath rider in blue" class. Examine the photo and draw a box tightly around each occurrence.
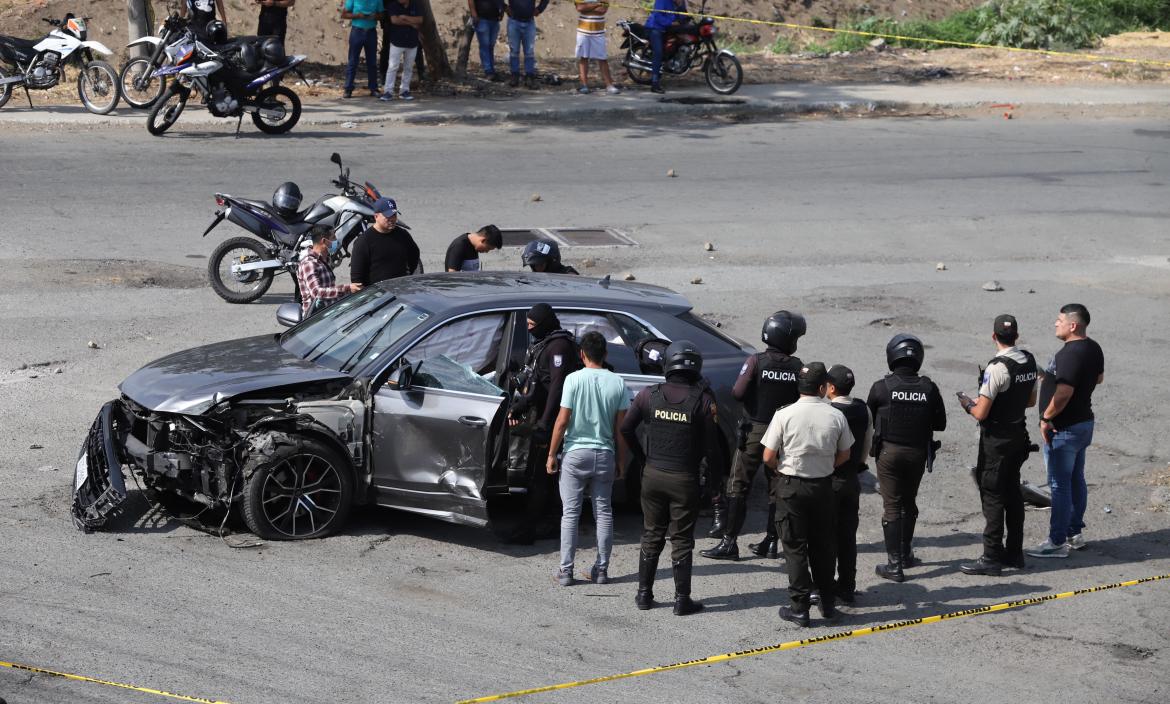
[618,0,743,95]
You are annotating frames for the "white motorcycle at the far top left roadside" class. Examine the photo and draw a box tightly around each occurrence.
[0,13,118,115]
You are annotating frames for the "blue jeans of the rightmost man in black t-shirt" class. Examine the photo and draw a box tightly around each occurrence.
[1044,421,1093,545]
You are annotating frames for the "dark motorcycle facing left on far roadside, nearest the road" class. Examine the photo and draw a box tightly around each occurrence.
[146,20,304,137]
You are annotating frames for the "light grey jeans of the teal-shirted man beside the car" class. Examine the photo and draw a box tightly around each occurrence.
[560,449,613,574]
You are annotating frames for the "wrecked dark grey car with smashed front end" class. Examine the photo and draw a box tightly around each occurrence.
[73,274,752,540]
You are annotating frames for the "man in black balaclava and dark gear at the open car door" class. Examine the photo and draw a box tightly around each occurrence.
[508,303,580,545]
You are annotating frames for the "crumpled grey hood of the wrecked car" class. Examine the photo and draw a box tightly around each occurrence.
[118,334,349,415]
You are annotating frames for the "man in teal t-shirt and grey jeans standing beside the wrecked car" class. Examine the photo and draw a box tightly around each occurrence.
[546,331,629,587]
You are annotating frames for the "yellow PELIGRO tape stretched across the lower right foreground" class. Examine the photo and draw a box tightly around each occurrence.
[456,574,1170,704]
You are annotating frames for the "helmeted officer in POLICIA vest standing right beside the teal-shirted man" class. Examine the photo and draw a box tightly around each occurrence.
[621,340,723,616]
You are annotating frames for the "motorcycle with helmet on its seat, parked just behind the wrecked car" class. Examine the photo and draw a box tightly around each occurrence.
[204,152,383,303]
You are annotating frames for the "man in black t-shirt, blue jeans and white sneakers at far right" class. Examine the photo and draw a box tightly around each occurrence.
[1025,303,1104,558]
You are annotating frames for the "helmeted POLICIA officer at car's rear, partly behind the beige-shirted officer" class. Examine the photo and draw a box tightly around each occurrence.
[700,310,807,560]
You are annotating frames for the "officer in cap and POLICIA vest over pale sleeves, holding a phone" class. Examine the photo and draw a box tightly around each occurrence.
[958,315,1037,577]
